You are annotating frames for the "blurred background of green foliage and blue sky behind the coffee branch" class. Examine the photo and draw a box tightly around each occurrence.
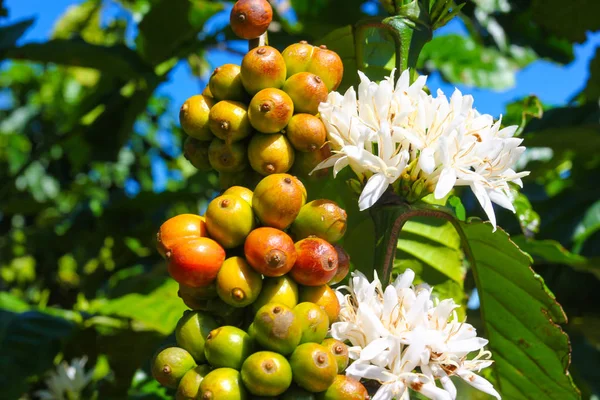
[0,0,600,399]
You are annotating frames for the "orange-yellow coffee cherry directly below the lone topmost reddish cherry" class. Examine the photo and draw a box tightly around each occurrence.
[241,46,286,95]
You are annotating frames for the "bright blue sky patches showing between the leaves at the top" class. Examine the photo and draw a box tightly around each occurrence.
[2,0,600,116]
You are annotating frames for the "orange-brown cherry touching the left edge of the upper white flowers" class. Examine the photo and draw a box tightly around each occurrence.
[285,115,327,154]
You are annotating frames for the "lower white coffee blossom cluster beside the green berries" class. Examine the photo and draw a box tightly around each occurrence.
[331,270,500,400]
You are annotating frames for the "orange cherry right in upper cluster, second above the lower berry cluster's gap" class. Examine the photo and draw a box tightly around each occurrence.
[282,72,328,115]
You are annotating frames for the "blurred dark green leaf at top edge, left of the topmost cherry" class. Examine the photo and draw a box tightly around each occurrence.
[135,0,223,66]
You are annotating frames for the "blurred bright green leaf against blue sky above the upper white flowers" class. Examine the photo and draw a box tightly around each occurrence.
[419,35,532,90]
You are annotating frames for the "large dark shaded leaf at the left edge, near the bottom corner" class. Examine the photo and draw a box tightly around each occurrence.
[0,293,76,399]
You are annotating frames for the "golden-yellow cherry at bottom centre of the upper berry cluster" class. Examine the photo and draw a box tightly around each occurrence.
[248,134,294,176]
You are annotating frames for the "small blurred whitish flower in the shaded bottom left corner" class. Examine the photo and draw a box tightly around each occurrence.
[35,357,93,400]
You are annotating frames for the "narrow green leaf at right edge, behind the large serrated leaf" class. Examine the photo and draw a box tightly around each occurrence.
[513,236,600,279]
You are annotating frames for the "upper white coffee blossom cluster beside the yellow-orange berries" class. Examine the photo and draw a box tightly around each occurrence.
[315,71,529,226]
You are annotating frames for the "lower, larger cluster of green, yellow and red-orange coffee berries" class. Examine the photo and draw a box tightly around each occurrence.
[152,174,368,400]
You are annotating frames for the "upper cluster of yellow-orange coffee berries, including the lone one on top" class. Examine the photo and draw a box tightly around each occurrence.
[179,0,343,187]
